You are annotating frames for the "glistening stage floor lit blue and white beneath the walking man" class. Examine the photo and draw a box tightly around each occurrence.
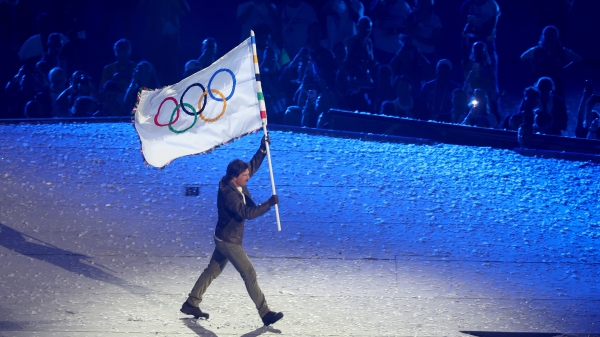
[0,124,600,337]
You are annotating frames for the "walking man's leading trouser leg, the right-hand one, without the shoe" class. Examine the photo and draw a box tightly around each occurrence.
[217,241,269,317]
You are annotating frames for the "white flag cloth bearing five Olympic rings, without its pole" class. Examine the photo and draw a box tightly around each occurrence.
[134,38,262,167]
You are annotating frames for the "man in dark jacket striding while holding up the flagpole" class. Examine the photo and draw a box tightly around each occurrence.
[180,136,283,325]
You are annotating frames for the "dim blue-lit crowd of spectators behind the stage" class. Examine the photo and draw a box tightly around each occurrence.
[0,0,600,139]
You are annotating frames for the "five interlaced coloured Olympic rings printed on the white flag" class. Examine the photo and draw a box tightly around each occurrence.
[154,68,237,133]
